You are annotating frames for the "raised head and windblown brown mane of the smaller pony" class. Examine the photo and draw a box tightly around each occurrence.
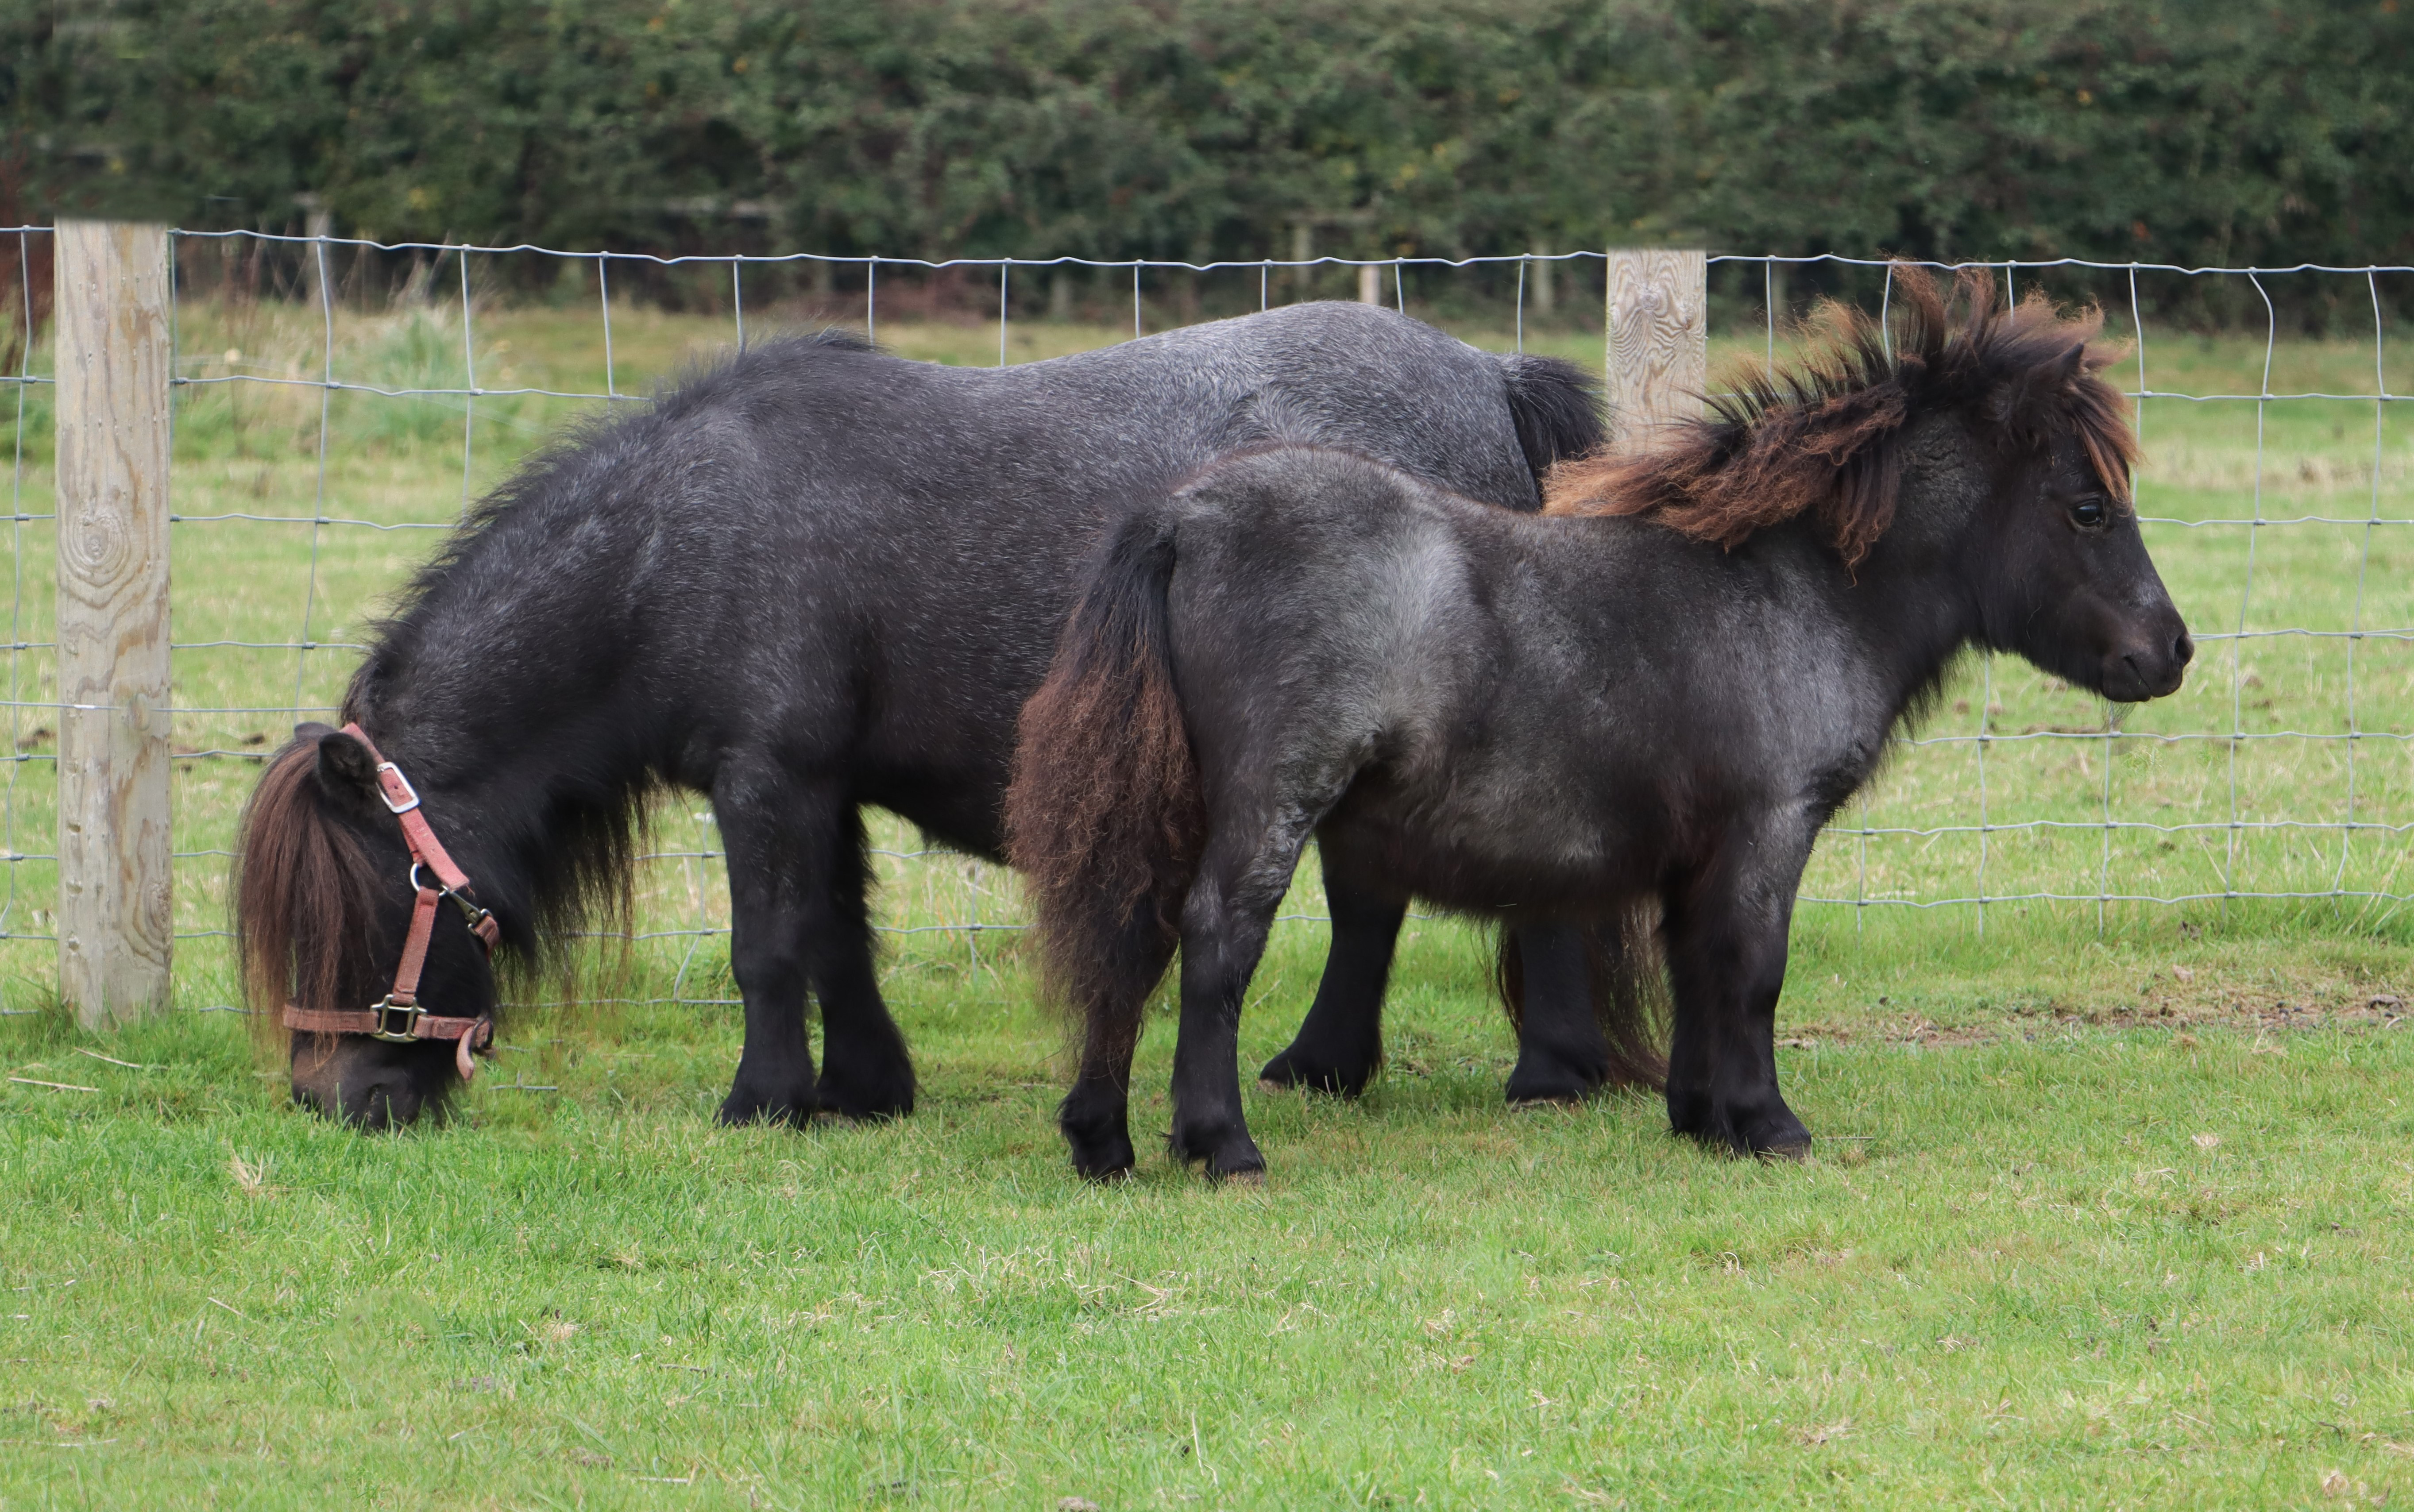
[1547,266,2194,703]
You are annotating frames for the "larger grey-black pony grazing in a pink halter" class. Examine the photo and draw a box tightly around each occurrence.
[234,305,1605,1128]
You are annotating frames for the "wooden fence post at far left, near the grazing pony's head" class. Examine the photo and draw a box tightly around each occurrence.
[55,220,174,1029]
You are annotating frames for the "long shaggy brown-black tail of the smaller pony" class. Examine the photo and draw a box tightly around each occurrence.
[1007,512,1207,1034]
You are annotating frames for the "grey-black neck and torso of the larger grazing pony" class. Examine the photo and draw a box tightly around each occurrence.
[348,302,1598,840]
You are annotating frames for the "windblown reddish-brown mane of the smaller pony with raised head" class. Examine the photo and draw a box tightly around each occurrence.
[1545,263,2136,565]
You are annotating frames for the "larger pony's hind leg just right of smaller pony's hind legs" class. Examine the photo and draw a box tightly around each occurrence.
[1258,833,1407,1096]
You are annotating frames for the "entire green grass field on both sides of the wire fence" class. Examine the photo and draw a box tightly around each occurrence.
[0,274,2414,1510]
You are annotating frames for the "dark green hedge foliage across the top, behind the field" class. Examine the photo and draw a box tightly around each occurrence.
[19,0,2414,274]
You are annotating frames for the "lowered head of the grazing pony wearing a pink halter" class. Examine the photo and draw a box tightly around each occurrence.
[234,725,497,1128]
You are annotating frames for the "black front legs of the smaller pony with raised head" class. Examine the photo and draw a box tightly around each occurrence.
[1666,836,1811,1154]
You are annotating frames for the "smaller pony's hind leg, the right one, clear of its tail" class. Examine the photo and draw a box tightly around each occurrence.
[1168,824,1309,1179]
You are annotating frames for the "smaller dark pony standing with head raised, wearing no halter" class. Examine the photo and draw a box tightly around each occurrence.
[1009,268,2192,1176]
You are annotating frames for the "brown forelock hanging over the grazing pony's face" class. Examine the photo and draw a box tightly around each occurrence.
[232,739,379,1046]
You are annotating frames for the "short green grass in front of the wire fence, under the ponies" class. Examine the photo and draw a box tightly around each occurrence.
[0,930,2414,1507]
